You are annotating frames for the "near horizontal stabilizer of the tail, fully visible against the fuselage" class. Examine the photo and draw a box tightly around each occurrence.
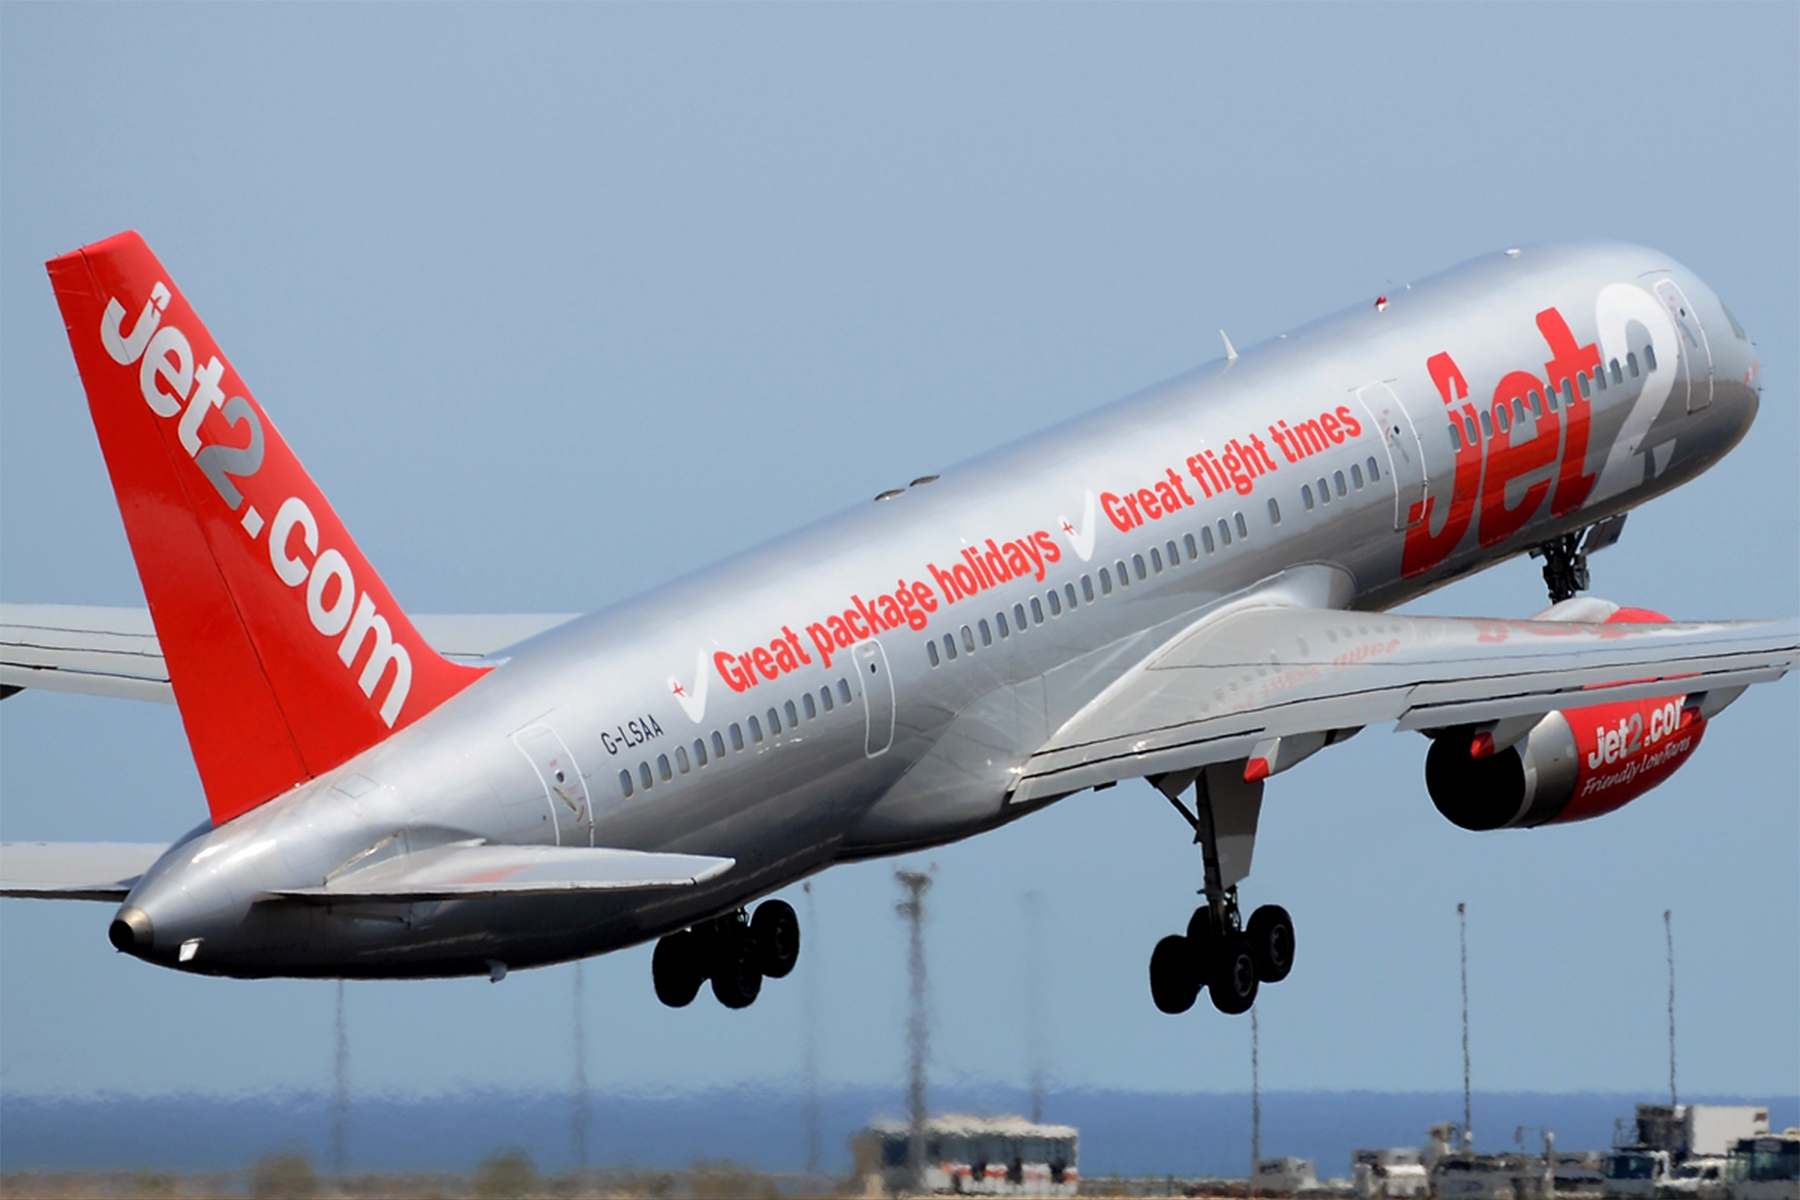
[270,842,736,903]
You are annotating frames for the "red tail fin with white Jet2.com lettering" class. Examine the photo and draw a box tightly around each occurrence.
[49,234,481,822]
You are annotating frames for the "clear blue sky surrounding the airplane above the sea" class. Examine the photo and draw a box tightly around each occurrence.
[0,4,1800,1129]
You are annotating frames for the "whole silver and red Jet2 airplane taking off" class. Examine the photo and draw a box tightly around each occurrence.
[0,232,1800,1013]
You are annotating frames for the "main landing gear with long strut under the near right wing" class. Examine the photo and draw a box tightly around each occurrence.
[1150,761,1294,1015]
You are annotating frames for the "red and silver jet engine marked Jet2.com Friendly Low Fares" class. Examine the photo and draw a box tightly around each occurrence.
[1426,599,1742,829]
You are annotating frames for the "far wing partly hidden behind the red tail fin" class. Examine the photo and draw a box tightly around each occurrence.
[0,604,572,703]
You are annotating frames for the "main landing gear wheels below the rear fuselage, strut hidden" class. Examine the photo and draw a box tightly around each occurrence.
[650,900,799,1007]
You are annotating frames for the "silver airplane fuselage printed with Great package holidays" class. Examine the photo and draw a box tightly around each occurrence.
[128,245,1759,977]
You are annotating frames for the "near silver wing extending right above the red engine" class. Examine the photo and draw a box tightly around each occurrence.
[1013,606,1800,801]
